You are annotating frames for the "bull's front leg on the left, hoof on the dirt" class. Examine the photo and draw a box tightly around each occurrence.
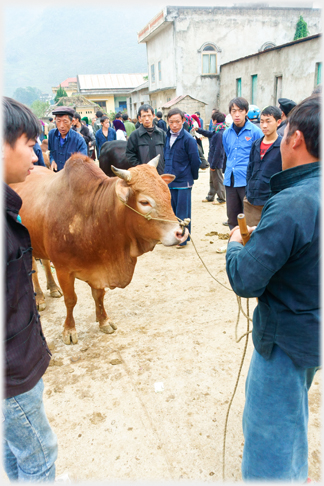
[56,268,78,344]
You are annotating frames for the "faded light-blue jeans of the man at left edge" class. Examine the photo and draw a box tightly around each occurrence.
[2,379,57,483]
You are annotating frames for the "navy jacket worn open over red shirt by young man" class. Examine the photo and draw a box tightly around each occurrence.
[245,135,282,206]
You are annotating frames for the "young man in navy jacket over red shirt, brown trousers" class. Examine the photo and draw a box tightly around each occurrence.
[243,106,282,226]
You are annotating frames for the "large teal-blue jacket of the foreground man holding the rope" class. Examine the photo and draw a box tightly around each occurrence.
[226,162,321,367]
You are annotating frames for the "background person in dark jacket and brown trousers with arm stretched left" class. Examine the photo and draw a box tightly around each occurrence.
[196,111,226,204]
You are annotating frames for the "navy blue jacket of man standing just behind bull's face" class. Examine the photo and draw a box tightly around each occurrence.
[164,128,201,189]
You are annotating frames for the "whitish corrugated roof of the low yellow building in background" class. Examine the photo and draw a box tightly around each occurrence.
[78,73,147,90]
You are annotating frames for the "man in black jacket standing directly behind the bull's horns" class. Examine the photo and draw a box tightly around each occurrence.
[126,104,166,175]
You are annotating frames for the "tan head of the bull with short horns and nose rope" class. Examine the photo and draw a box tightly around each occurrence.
[111,155,188,247]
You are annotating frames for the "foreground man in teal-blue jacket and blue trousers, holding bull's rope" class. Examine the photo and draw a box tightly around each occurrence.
[226,96,321,483]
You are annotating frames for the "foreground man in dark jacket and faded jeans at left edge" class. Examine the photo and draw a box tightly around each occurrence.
[2,97,57,483]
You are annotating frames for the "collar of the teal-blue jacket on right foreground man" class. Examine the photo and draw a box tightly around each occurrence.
[270,162,320,194]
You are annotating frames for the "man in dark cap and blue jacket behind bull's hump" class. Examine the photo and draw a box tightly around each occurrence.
[48,106,88,172]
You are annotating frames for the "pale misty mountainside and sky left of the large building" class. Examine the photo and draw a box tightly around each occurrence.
[3,3,161,96]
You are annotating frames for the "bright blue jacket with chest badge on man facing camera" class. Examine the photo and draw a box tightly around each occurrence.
[223,121,263,187]
